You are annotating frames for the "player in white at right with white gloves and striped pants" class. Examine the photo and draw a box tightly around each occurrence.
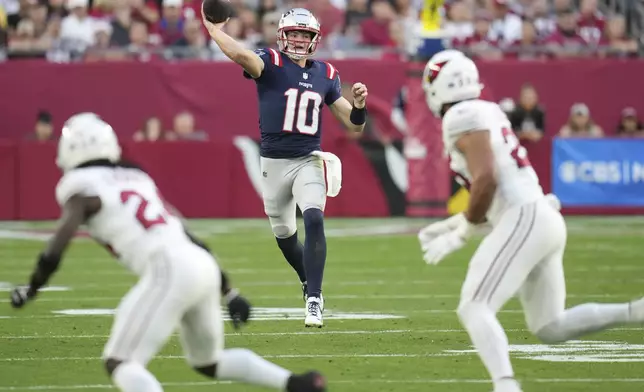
[419,53,644,392]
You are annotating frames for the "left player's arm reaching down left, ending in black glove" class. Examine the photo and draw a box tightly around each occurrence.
[11,195,101,308]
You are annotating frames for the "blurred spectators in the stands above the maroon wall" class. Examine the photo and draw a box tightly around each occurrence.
[0,0,638,61]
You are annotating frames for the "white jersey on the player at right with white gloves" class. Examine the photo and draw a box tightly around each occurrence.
[443,100,544,225]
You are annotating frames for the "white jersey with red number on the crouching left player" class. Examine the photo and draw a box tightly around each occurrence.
[56,167,190,274]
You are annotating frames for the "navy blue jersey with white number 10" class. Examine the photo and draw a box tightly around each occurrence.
[244,49,342,158]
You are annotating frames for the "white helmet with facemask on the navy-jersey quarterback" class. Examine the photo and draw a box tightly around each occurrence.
[277,8,320,60]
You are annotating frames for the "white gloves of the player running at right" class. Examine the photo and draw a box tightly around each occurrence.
[419,213,476,265]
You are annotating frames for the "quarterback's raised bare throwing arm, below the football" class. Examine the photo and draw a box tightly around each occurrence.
[201,9,264,79]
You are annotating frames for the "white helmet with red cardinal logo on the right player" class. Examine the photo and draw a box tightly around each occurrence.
[423,50,483,117]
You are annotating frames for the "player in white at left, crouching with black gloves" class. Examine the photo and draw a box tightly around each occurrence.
[11,113,326,392]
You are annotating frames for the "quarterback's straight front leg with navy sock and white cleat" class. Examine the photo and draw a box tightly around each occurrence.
[293,157,326,328]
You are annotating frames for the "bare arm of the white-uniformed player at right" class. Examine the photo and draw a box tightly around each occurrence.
[455,131,497,224]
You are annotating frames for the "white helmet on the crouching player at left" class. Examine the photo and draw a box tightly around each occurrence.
[56,113,121,172]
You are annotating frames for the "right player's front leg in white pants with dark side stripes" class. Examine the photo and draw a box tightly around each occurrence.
[457,204,542,392]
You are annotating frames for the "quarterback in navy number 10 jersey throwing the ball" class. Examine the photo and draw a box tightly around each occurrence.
[202,8,367,328]
